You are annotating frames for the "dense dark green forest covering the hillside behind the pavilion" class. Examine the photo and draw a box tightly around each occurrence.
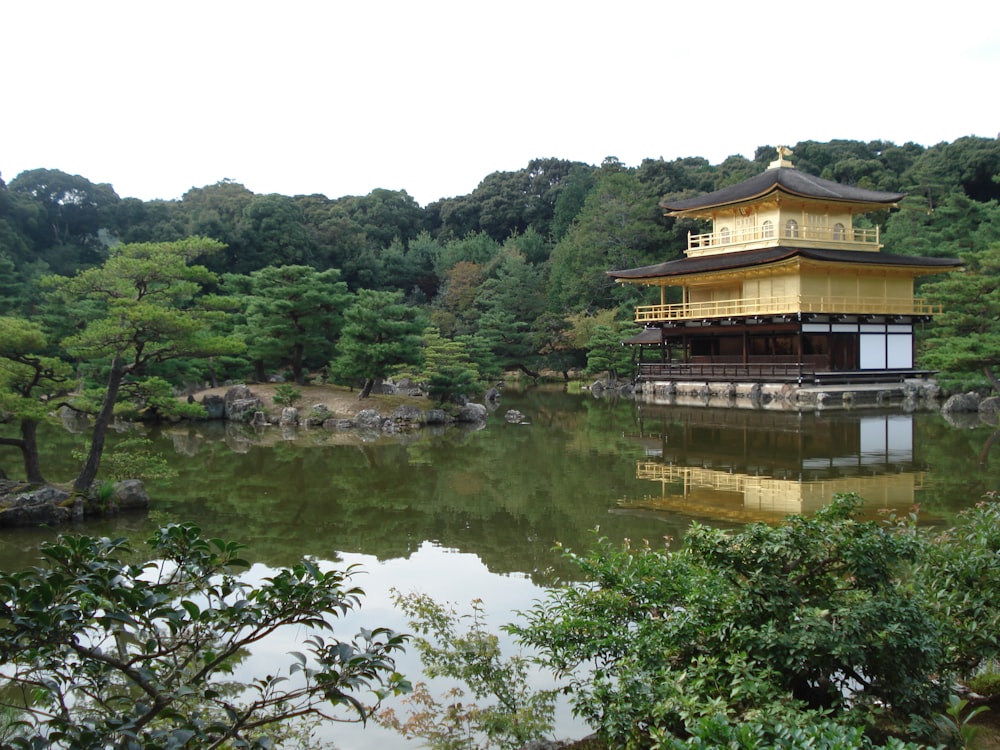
[0,137,1000,394]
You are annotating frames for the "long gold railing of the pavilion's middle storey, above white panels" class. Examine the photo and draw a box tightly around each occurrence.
[635,295,941,323]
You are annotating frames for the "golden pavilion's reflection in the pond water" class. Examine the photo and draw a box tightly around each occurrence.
[619,407,925,523]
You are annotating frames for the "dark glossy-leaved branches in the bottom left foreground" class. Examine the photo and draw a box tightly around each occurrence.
[0,526,408,750]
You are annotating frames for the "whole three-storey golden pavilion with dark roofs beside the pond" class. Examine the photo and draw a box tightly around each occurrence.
[608,147,961,403]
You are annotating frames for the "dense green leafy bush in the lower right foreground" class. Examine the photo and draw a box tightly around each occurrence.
[509,495,1000,748]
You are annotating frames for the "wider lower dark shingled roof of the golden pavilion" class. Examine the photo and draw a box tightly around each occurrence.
[606,247,962,281]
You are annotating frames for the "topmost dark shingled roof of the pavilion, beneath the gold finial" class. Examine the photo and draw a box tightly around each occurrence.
[660,167,906,212]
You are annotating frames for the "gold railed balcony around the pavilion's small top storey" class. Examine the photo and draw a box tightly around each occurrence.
[687,219,882,256]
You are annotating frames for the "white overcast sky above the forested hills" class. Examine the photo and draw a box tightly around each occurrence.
[0,0,1000,205]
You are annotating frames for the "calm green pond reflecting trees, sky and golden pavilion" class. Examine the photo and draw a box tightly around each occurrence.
[0,389,1000,750]
